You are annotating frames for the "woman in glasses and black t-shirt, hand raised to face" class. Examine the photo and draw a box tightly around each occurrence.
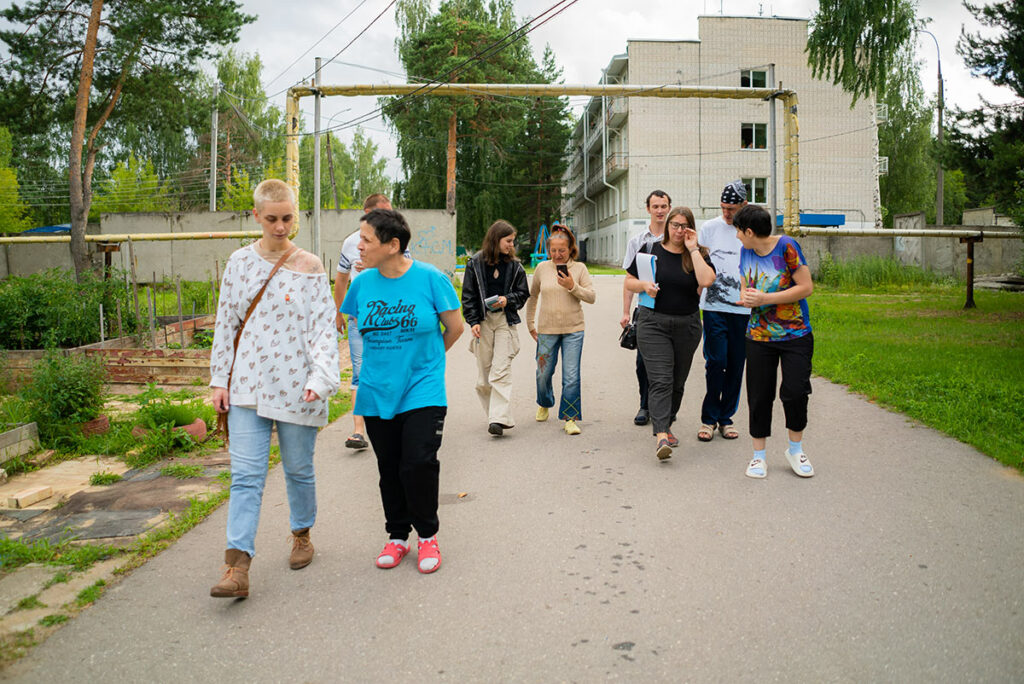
[626,207,715,461]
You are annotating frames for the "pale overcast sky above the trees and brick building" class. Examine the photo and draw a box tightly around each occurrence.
[0,0,1015,176]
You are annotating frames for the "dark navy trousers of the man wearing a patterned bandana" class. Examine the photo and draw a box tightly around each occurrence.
[700,310,750,426]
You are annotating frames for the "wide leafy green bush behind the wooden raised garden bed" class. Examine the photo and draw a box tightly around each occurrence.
[0,268,135,349]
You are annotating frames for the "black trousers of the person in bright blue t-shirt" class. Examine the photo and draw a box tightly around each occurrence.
[366,407,447,540]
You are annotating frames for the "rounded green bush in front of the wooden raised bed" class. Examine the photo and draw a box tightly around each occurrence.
[22,349,106,440]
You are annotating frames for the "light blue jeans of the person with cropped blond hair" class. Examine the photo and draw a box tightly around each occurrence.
[227,407,316,556]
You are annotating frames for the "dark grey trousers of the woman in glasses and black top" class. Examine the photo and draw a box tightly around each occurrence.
[637,307,701,434]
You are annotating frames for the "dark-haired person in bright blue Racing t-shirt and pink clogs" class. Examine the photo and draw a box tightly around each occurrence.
[341,209,463,572]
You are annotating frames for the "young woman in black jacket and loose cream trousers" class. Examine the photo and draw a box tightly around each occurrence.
[462,220,529,437]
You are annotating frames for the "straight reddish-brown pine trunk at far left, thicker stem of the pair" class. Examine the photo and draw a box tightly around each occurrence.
[69,0,103,281]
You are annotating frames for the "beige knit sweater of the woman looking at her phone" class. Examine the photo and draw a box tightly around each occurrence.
[526,260,596,335]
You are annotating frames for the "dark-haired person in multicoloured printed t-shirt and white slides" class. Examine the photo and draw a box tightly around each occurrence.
[732,205,814,478]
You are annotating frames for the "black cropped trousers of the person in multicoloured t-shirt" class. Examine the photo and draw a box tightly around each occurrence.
[746,333,814,438]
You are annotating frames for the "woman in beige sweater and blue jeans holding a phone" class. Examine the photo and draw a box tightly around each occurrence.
[526,223,595,434]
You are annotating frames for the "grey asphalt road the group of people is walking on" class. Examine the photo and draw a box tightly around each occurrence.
[6,276,1024,682]
